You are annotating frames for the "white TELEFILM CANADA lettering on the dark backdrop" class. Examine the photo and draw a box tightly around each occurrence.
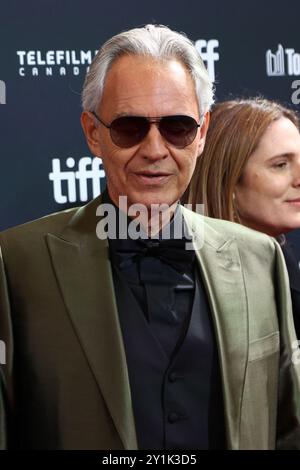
[16,49,98,77]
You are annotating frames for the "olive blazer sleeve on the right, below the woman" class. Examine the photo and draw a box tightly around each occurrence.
[275,243,300,449]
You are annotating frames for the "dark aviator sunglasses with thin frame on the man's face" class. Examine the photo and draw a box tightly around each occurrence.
[92,111,200,148]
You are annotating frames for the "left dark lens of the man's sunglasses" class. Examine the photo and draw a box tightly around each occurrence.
[110,116,150,148]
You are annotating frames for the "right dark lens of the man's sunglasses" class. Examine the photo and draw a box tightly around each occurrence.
[159,116,198,148]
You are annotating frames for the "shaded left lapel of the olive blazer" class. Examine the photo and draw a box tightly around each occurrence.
[47,199,137,449]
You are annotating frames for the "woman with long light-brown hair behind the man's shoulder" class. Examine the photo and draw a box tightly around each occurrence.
[183,98,300,338]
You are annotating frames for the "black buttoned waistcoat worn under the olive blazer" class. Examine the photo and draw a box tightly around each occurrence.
[113,268,225,449]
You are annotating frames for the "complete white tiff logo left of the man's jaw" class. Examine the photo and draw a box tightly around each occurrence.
[49,157,105,204]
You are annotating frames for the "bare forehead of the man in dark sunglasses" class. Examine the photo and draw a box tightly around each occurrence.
[99,56,198,119]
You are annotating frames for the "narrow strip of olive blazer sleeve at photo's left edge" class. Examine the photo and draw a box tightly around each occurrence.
[0,244,13,449]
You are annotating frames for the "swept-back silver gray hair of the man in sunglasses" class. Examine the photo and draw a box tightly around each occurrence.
[82,24,214,114]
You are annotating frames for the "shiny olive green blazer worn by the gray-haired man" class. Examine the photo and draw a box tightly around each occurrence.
[0,198,300,449]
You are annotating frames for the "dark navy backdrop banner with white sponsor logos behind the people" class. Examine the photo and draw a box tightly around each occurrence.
[0,0,300,250]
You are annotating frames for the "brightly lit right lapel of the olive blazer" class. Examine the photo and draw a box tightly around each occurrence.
[184,211,249,449]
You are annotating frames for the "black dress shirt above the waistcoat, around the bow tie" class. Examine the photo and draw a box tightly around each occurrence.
[103,191,195,357]
